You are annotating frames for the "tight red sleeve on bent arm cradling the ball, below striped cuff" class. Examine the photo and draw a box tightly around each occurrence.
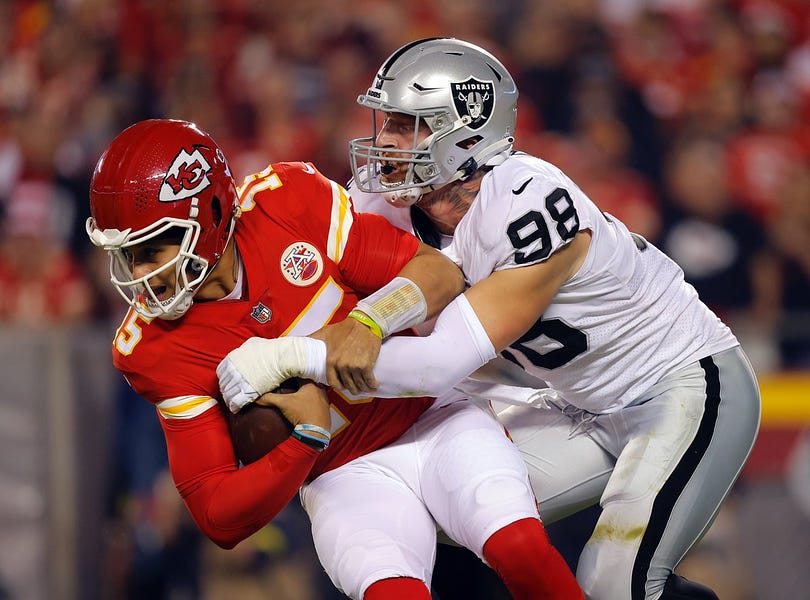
[158,408,318,548]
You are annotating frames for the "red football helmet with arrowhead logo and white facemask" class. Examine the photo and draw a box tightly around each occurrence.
[87,119,239,319]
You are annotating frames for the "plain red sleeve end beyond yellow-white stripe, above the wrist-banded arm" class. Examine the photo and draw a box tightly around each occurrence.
[340,213,419,294]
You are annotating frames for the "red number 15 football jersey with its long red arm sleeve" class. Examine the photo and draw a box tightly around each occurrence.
[113,163,432,547]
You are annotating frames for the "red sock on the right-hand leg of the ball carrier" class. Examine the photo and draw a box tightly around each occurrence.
[484,519,585,600]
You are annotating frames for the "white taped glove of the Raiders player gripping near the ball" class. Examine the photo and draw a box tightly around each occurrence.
[217,337,326,414]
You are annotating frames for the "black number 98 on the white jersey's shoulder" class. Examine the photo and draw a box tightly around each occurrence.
[506,188,579,265]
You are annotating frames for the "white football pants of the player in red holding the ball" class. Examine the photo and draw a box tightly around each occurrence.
[301,400,539,599]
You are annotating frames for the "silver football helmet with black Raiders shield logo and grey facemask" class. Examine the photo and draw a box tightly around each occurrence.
[349,38,518,206]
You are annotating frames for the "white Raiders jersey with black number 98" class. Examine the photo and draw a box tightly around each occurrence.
[351,153,738,413]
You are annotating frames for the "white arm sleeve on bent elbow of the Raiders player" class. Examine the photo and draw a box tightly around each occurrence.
[366,295,495,398]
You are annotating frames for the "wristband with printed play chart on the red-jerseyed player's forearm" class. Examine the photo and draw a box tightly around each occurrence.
[355,277,427,338]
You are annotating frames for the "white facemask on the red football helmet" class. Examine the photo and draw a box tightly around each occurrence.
[87,217,211,320]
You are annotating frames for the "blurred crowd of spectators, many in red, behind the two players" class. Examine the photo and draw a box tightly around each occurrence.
[0,0,810,600]
